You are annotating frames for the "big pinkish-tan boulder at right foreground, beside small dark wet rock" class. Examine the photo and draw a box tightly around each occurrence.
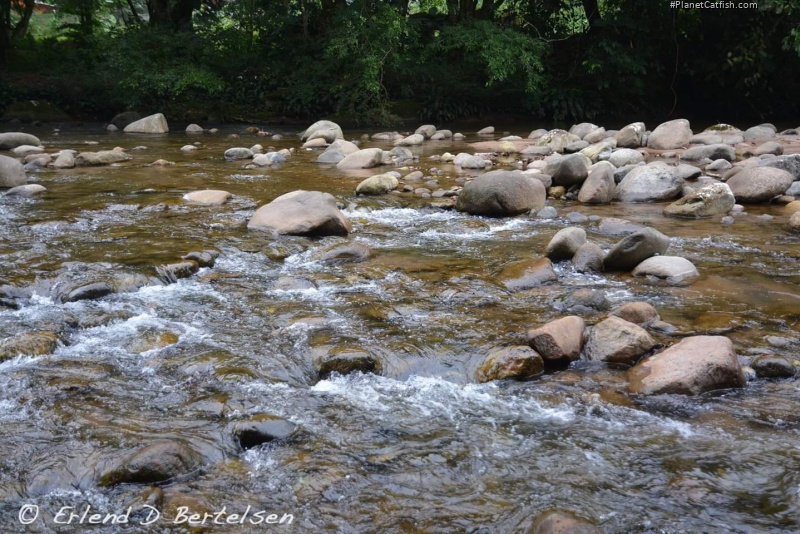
[628,336,745,395]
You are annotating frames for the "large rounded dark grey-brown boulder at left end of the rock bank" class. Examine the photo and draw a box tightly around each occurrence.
[456,171,547,217]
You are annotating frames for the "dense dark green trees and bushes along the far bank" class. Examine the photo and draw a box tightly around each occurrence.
[0,0,800,123]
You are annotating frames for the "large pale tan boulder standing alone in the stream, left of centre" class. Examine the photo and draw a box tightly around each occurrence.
[247,190,351,236]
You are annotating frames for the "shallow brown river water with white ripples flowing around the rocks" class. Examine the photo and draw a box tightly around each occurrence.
[0,124,800,533]
